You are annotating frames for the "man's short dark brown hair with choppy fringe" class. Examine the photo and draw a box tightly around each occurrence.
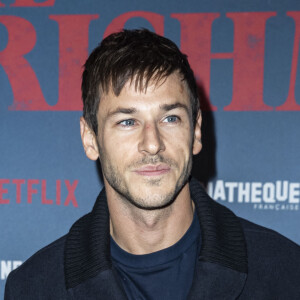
[81,29,200,134]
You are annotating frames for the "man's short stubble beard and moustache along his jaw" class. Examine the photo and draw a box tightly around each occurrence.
[99,147,192,211]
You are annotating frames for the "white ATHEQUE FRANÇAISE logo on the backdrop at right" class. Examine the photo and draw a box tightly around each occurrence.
[207,180,300,211]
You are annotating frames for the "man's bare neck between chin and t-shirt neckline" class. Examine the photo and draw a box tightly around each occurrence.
[107,183,194,254]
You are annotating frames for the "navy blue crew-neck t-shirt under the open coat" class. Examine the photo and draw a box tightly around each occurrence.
[111,213,200,300]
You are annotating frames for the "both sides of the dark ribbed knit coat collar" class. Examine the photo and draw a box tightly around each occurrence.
[64,179,247,298]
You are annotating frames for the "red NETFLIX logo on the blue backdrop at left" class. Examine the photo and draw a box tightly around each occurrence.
[0,179,78,207]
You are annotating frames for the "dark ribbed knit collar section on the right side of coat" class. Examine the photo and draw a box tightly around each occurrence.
[190,179,248,273]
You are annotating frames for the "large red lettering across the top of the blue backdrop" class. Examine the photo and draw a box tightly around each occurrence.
[0,10,300,111]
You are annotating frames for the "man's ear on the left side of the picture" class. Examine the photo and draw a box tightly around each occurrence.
[80,117,99,160]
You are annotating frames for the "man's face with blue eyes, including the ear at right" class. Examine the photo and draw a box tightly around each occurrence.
[81,73,201,209]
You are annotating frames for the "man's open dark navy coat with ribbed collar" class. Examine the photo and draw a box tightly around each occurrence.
[5,180,300,300]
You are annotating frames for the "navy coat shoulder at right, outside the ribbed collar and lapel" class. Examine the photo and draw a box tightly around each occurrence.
[240,219,300,299]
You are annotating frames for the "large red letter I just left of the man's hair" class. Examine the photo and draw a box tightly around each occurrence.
[49,15,99,111]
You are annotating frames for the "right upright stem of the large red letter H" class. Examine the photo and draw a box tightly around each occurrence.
[224,12,276,111]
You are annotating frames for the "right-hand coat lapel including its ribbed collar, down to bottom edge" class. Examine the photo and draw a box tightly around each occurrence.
[189,179,248,300]
